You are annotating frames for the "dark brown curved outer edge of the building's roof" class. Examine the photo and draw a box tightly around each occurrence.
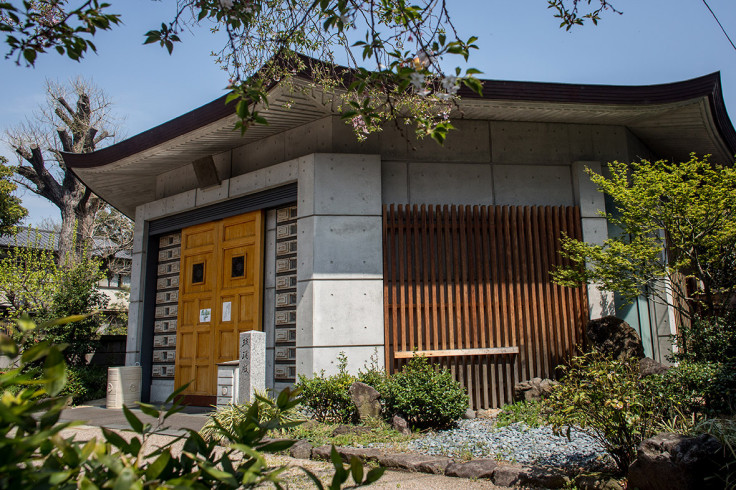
[62,70,736,170]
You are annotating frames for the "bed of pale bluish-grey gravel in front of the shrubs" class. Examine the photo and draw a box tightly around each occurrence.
[408,419,613,470]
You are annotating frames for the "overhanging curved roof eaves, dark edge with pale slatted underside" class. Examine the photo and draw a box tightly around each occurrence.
[63,61,736,217]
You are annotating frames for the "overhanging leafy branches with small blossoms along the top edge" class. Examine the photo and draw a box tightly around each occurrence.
[0,0,616,142]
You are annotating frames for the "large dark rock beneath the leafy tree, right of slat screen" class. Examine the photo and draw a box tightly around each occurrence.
[585,316,644,359]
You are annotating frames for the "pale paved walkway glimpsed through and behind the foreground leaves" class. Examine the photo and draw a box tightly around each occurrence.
[61,400,507,490]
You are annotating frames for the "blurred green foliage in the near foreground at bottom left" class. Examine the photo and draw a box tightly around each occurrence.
[0,317,383,489]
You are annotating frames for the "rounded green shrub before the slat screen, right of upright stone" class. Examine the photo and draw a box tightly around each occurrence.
[384,357,468,429]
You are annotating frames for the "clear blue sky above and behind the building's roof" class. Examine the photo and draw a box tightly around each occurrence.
[0,0,736,223]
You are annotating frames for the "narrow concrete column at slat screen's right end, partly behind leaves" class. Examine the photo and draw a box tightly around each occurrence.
[572,162,616,318]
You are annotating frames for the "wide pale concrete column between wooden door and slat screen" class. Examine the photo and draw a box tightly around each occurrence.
[296,153,384,376]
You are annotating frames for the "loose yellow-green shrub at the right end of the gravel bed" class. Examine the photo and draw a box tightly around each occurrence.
[544,352,659,474]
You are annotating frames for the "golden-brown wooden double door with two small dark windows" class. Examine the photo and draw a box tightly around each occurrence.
[174,211,263,405]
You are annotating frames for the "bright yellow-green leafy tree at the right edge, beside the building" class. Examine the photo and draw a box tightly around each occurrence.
[553,155,736,318]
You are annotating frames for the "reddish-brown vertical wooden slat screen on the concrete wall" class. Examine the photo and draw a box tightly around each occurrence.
[383,205,588,408]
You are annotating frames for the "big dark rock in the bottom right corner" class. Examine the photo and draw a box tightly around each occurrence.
[629,432,724,490]
